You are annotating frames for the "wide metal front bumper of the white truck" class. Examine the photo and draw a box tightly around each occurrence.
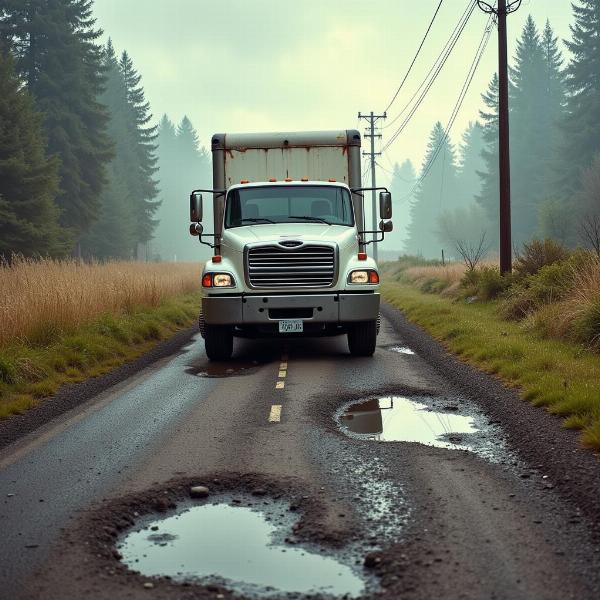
[202,292,380,325]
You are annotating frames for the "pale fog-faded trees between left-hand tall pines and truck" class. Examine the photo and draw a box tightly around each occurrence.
[153,115,213,261]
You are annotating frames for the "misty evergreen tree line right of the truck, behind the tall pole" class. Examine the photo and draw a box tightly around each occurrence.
[391,0,600,258]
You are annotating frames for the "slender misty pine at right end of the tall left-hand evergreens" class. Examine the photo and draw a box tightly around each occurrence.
[119,52,160,252]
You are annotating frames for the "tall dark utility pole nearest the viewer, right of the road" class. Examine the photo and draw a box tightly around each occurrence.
[477,0,522,275]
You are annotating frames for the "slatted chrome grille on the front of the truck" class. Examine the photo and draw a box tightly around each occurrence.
[246,245,335,288]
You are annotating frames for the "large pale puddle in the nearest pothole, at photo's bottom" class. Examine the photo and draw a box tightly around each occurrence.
[118,504,365,597]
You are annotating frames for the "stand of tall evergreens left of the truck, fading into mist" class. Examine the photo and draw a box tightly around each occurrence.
[0,0,204,259]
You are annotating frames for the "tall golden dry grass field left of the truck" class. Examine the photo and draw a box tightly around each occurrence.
[0,258,201,346]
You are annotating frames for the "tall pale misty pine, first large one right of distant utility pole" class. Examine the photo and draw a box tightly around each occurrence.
[406,122,456,258]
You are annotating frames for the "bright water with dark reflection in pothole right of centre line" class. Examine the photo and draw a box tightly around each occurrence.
[340,396,480,451]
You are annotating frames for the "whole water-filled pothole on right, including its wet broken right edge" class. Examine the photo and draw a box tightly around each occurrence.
[337,396,502,458]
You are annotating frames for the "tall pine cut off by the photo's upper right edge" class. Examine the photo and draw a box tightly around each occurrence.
[561,0,600,192]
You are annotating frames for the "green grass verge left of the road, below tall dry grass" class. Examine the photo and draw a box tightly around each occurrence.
[0,294,200,419]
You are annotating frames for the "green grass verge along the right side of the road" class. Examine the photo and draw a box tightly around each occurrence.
[383,283,600,448]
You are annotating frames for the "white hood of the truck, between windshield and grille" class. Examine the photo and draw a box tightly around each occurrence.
[222,223,357,252]
